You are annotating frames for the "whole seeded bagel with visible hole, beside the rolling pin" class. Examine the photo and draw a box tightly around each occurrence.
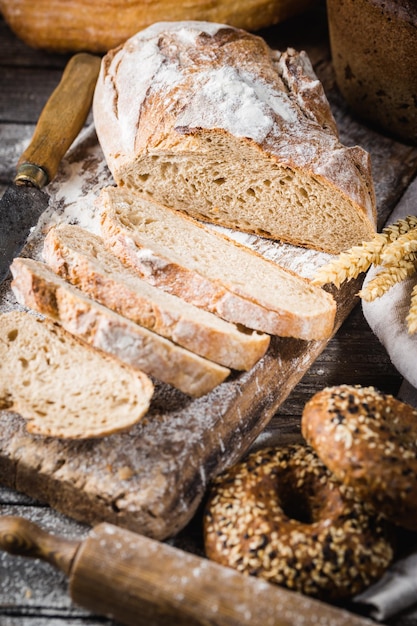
[204,444,393,600]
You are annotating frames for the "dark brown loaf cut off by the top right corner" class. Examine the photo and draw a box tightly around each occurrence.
[327,0,417,145]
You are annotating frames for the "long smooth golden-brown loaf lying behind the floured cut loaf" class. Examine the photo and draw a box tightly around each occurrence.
[0,0,317,52]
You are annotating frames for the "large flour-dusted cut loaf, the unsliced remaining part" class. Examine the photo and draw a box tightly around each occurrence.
[93,22,376,254]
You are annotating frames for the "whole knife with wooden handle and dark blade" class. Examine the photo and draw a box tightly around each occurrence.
[0,53,101,283]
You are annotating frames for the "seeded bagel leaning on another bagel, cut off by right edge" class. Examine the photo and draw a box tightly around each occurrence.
[302,385,417,530]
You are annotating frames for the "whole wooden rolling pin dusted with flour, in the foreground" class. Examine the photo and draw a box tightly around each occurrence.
[0,516,373,626]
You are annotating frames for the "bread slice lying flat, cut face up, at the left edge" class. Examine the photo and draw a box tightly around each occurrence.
[0,311,153,439]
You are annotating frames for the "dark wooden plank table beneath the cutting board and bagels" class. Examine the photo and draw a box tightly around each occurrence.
[0,6,417,626]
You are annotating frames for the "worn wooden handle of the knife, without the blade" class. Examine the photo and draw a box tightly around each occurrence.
[15,53,101,188]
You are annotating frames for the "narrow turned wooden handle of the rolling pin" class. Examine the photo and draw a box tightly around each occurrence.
[0,515,80,576]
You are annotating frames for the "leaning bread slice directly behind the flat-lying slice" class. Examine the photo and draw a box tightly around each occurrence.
[11,258,230,397]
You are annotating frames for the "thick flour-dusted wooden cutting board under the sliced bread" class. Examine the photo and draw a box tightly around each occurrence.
[0,57,417,539]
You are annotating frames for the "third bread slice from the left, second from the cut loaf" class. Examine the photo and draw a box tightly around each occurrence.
[43,224,270,370]
